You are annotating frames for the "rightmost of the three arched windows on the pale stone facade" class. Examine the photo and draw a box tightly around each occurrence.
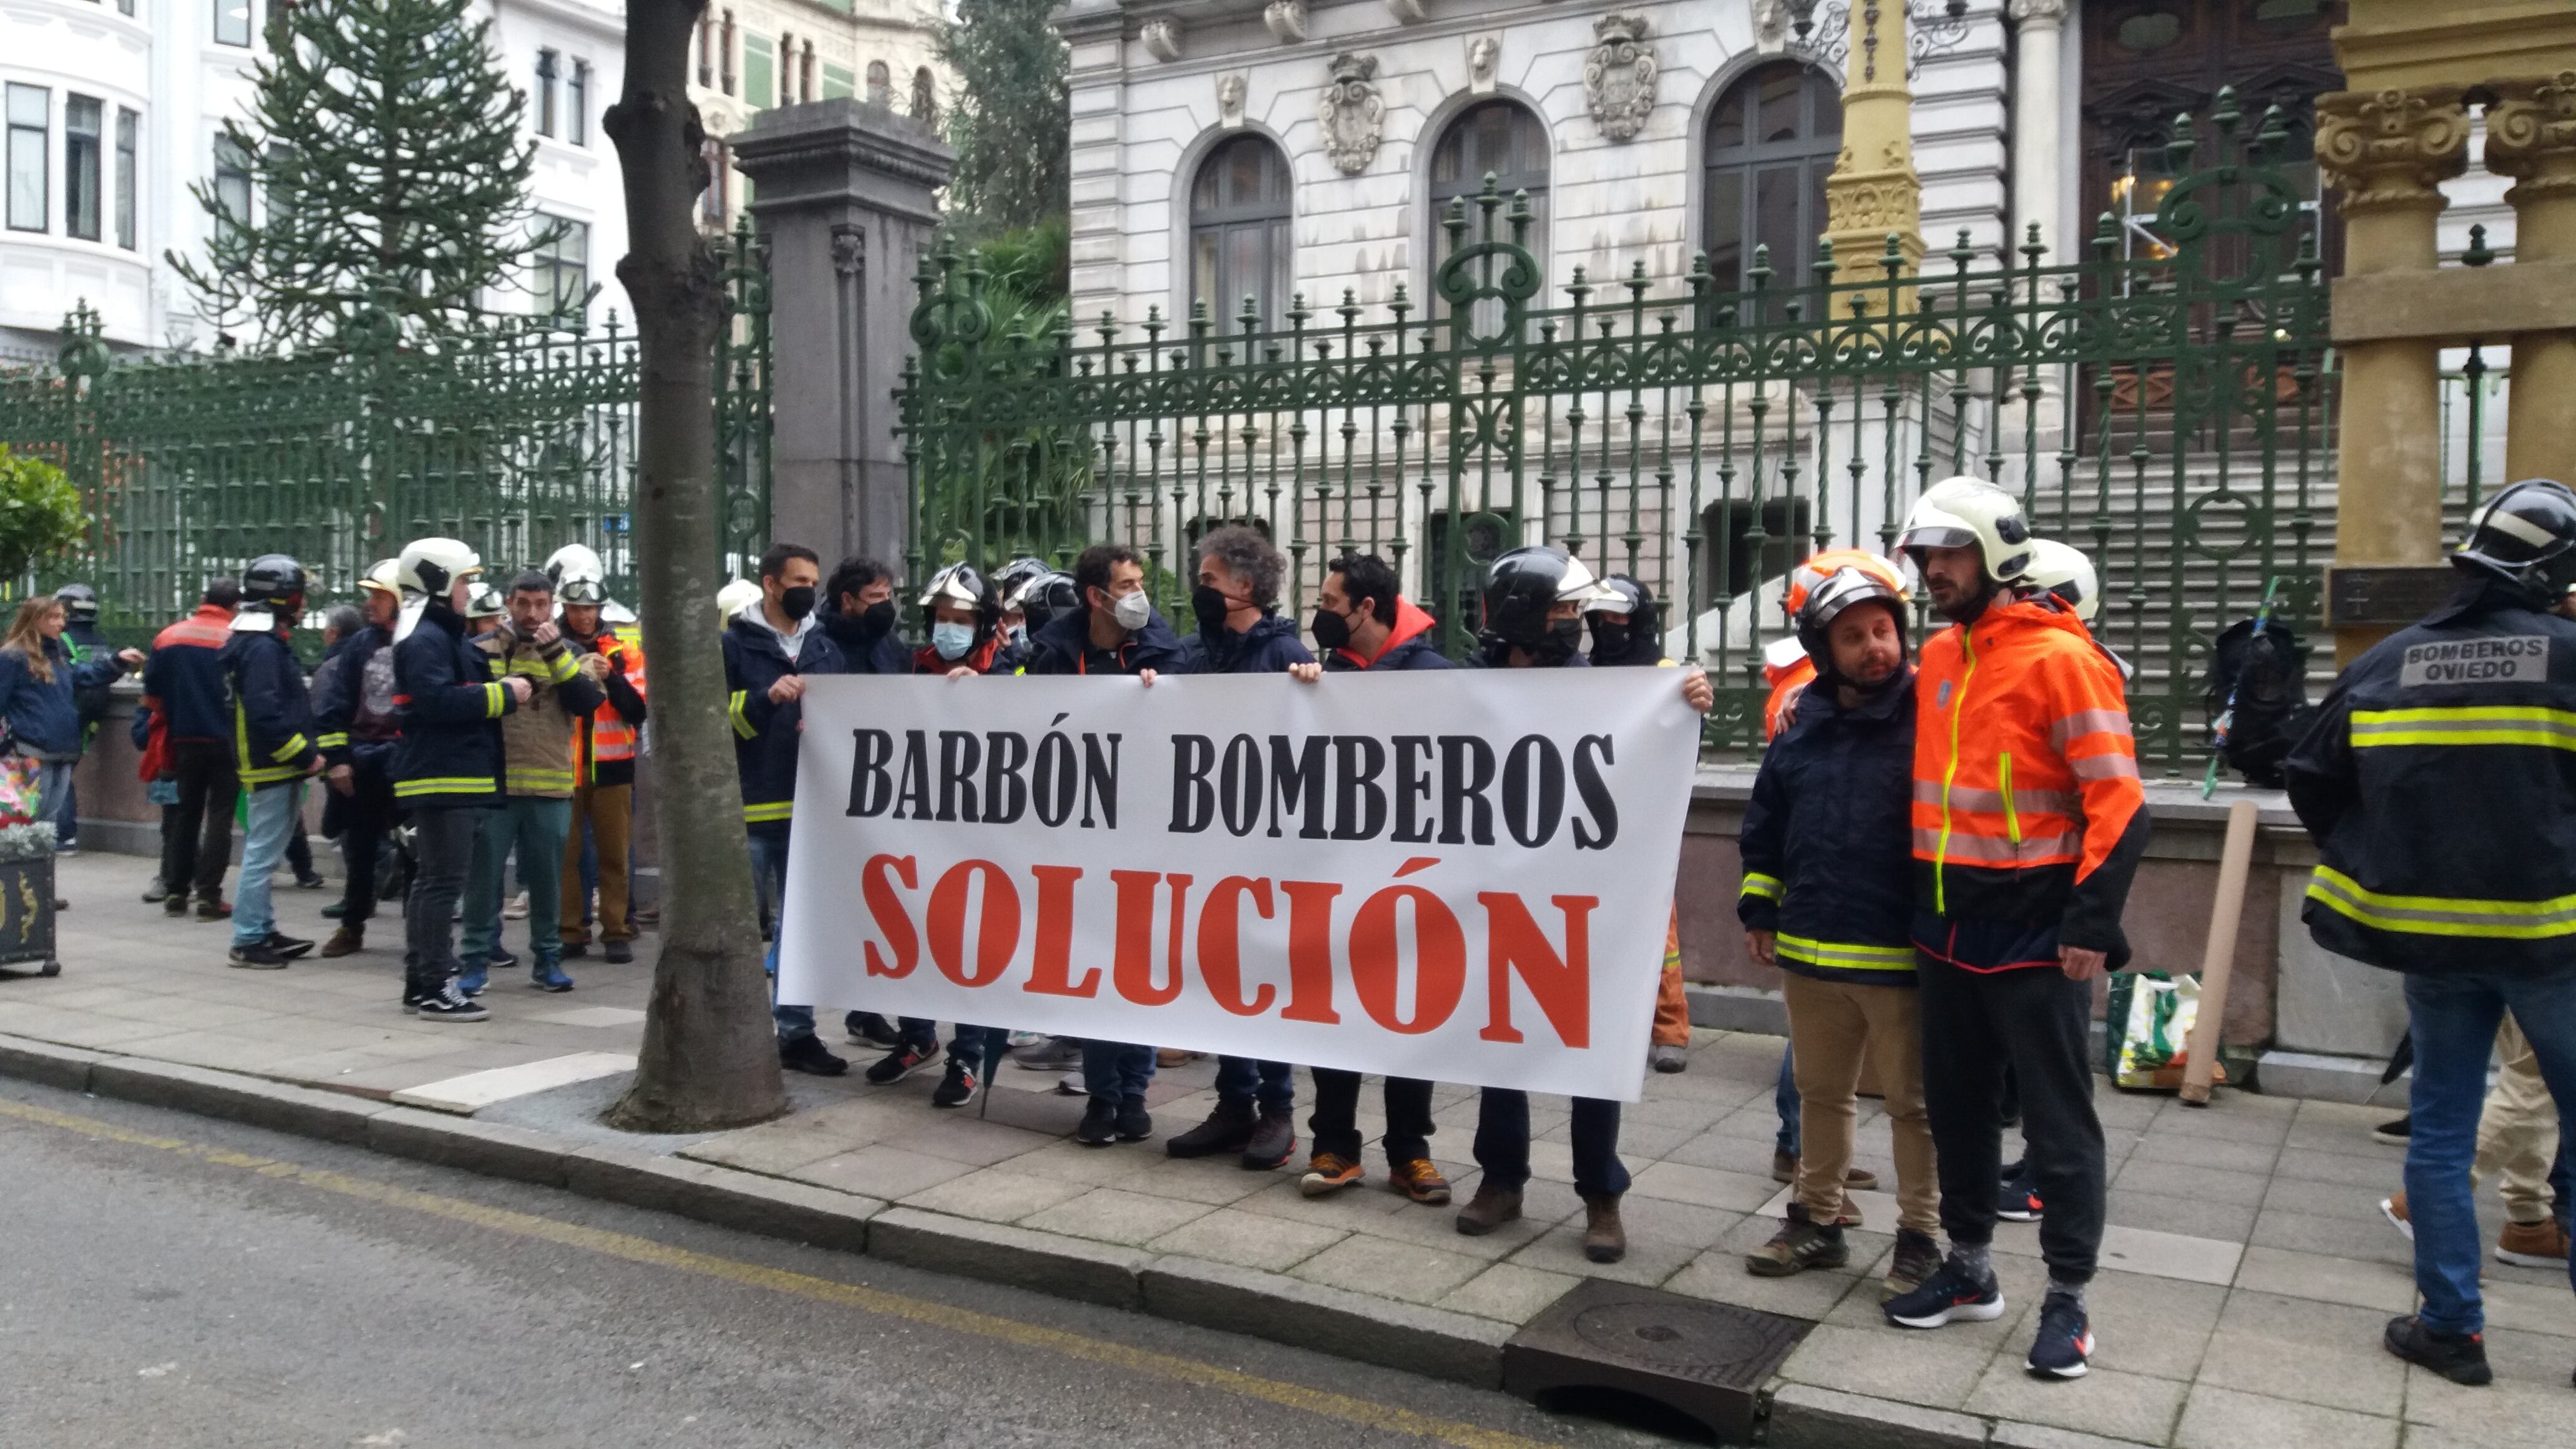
[1700,62,1870,291]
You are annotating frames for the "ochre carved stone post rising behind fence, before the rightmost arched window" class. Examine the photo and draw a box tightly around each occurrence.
[1823,0,1925,281]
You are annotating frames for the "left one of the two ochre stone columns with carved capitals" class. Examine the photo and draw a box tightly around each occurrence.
[2316,85,2468,668]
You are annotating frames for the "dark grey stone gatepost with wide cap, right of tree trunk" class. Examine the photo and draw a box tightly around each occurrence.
[729,98,955,570]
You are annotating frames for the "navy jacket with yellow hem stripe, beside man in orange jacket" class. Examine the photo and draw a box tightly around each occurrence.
[1736,681,1914,985]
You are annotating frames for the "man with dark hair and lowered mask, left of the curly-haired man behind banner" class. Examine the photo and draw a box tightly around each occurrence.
[1025,544,1190,1148]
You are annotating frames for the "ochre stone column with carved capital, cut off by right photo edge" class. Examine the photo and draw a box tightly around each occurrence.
[2486,70,2576,482]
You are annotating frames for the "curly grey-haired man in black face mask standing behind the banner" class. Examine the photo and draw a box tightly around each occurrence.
[1164,524,1314,1173]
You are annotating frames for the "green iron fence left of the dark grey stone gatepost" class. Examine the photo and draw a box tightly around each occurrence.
[0,224,770,640]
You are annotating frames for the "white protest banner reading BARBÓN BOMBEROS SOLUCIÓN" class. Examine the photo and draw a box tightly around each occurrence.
[778,668,1700,1101]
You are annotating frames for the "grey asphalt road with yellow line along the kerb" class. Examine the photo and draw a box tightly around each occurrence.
[0,1083,1654,1449]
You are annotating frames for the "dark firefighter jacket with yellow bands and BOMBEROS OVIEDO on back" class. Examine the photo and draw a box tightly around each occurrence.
[2285,583,2576,972]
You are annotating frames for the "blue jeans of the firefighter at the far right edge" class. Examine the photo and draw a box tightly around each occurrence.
[2406,967,2576,1333]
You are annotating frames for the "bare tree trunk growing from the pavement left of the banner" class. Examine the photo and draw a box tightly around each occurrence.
[603,0,786,1132]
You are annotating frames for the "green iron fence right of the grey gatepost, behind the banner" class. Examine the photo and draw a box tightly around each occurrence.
[902,98,2334,771]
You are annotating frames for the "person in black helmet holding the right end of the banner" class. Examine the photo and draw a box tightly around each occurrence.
[1458,547,1715,1264]
